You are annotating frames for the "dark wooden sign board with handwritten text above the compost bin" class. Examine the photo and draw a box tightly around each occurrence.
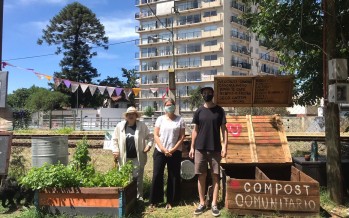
[214,76,293,107]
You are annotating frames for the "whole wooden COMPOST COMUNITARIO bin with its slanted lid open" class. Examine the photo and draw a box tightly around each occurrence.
[222,115,320,216]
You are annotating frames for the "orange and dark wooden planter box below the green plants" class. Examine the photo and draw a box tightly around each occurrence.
[35,180,137,217]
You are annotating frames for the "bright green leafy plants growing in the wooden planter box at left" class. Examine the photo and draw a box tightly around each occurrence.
[20,137,133,190]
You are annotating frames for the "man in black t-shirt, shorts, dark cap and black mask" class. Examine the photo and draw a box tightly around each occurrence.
[189,87,228,216]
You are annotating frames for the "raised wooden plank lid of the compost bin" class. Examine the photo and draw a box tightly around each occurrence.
[221,115,292,165]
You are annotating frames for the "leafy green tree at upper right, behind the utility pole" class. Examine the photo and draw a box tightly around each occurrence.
[243,0,349,105]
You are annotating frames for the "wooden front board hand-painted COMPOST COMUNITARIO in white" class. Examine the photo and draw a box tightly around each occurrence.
[226,179,320,212]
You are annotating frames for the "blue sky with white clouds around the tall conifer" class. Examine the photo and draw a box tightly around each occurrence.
[2,0,138,94]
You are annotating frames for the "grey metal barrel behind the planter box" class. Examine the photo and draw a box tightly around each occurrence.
[31,136,68,167]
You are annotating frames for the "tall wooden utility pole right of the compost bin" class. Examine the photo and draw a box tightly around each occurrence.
[322,0,343,204]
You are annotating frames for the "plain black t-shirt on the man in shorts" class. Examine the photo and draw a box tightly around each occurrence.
[192,105,227,151]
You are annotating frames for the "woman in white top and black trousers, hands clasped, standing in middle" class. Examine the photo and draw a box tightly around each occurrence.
[149,98,185,209]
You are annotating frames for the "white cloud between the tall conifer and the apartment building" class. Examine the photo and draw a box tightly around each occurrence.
[100,18,138,41]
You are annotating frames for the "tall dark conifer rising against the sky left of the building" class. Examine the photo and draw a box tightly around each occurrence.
[38,2,108,106]
